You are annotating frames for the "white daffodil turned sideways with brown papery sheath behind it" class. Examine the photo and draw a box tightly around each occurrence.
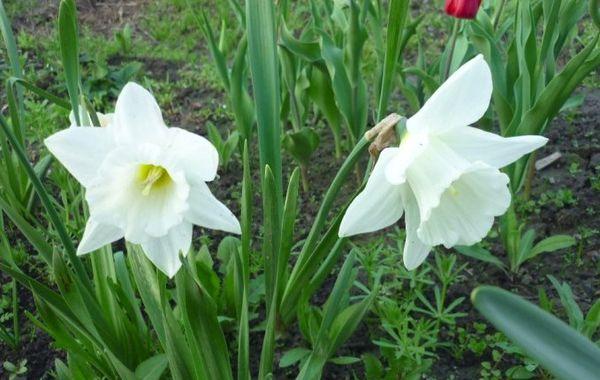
[339,55,548,269]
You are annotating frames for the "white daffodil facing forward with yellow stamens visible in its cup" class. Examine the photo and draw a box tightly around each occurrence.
[45,83,240,277]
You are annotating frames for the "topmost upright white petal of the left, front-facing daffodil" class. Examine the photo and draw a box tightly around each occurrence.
[114,82,167,143]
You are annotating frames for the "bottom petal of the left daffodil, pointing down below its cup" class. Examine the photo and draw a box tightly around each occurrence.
[141,223,193,278]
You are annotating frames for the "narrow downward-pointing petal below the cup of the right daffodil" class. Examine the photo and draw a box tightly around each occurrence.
[401,185,432,270]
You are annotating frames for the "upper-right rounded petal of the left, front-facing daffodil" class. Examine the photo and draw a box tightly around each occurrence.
[165,128,219,183]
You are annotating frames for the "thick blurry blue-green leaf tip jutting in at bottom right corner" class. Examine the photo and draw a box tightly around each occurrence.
[471,286,600,380]
